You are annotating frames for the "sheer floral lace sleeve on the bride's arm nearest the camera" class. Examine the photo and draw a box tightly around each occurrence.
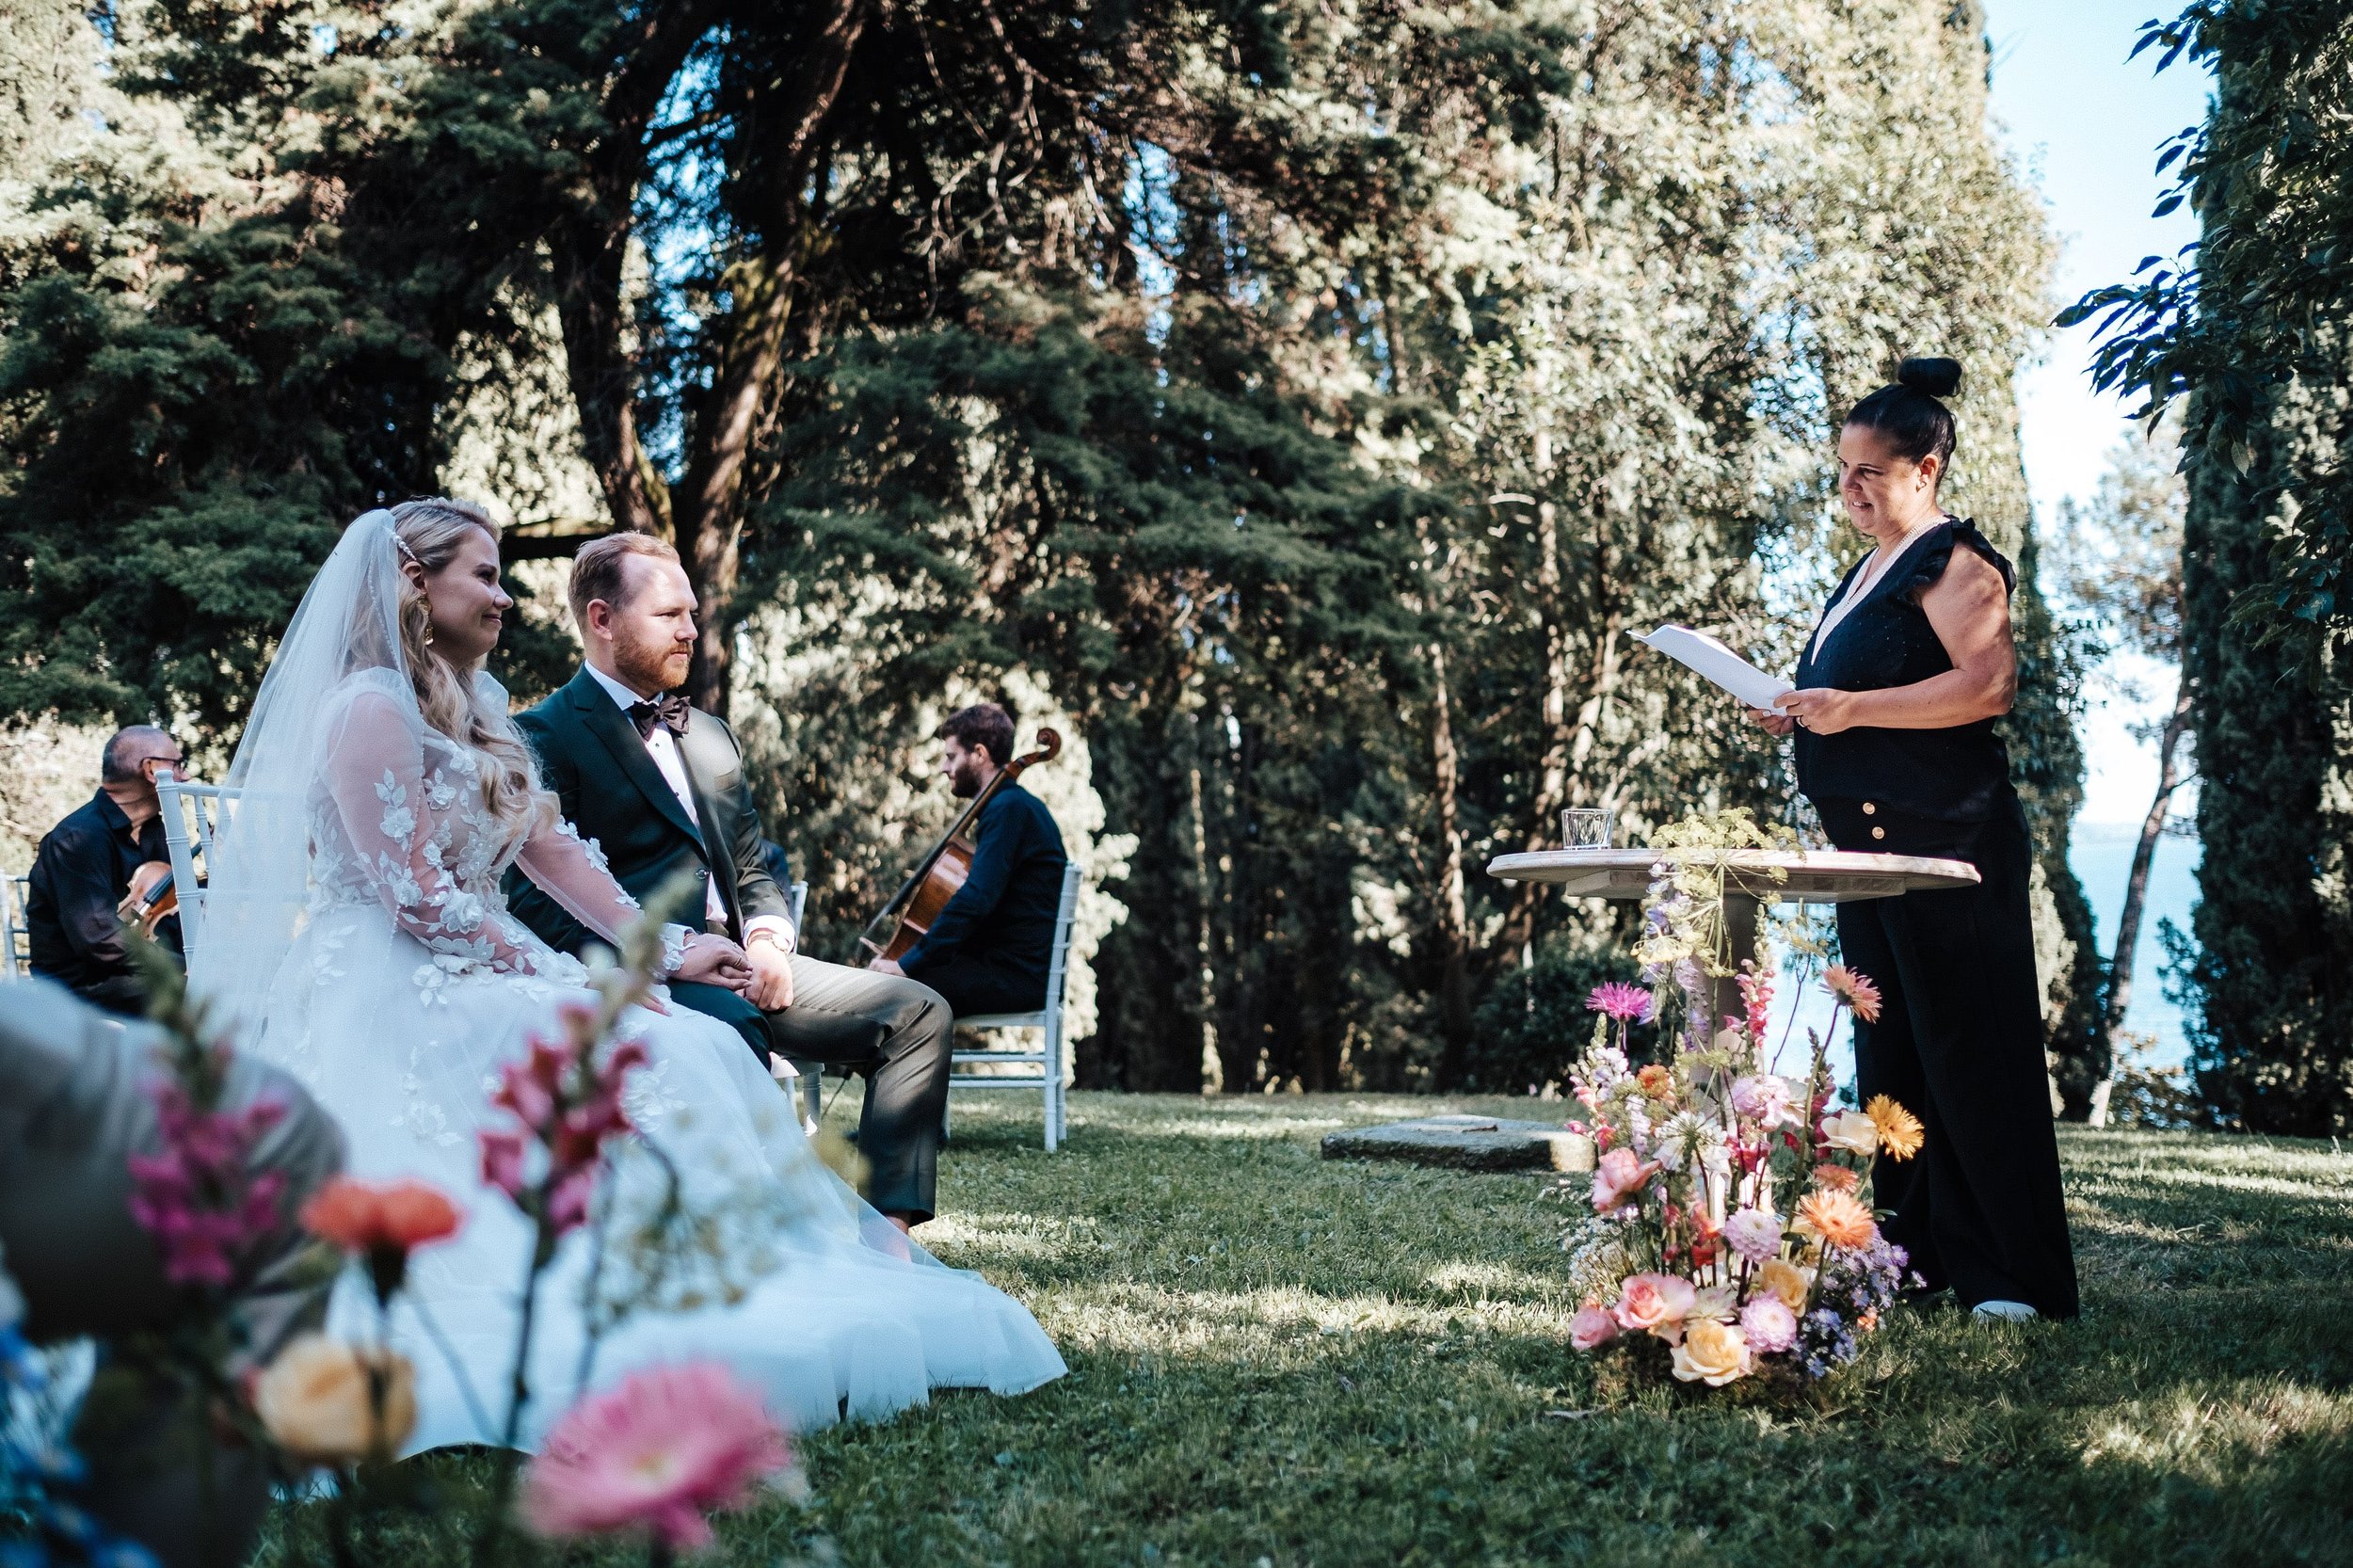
[328,692,527,970]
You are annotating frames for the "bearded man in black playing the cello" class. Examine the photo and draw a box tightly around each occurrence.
[869,701,1068,1017]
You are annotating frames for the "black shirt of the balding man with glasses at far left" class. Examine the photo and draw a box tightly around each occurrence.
[24,789,179,1013]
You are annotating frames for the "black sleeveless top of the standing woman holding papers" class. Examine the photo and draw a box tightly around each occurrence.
[1796,520,2019,822]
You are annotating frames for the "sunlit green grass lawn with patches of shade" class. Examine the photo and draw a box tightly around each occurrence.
[275,1095,2353,1568]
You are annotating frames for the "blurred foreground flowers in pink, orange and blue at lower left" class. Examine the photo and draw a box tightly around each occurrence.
[0,878,798,1568]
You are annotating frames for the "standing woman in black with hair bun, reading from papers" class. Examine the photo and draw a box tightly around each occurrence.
[1758,360,2075,1319]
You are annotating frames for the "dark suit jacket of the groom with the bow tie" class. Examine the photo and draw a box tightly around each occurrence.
[506,668,793,953]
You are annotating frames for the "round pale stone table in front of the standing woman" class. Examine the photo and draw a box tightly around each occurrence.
[1487,850,1979,1015]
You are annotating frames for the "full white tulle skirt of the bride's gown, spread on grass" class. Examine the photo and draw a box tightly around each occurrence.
[257,904,1066,1452]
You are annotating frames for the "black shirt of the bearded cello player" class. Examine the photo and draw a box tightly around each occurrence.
[899,784,1068,986]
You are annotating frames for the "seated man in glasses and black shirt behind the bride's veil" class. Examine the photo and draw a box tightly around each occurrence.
[24,725,182,1015]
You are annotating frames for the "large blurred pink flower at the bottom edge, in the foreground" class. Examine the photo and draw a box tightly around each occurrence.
[522,1363,793,1551]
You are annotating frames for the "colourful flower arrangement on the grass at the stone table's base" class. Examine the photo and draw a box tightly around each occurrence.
[1556,812,1923,1389]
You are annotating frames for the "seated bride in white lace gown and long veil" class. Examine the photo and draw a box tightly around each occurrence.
[191,499,1064,1452]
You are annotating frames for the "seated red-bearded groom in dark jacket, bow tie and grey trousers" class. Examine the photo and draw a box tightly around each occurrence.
[506,535,951,1229]
